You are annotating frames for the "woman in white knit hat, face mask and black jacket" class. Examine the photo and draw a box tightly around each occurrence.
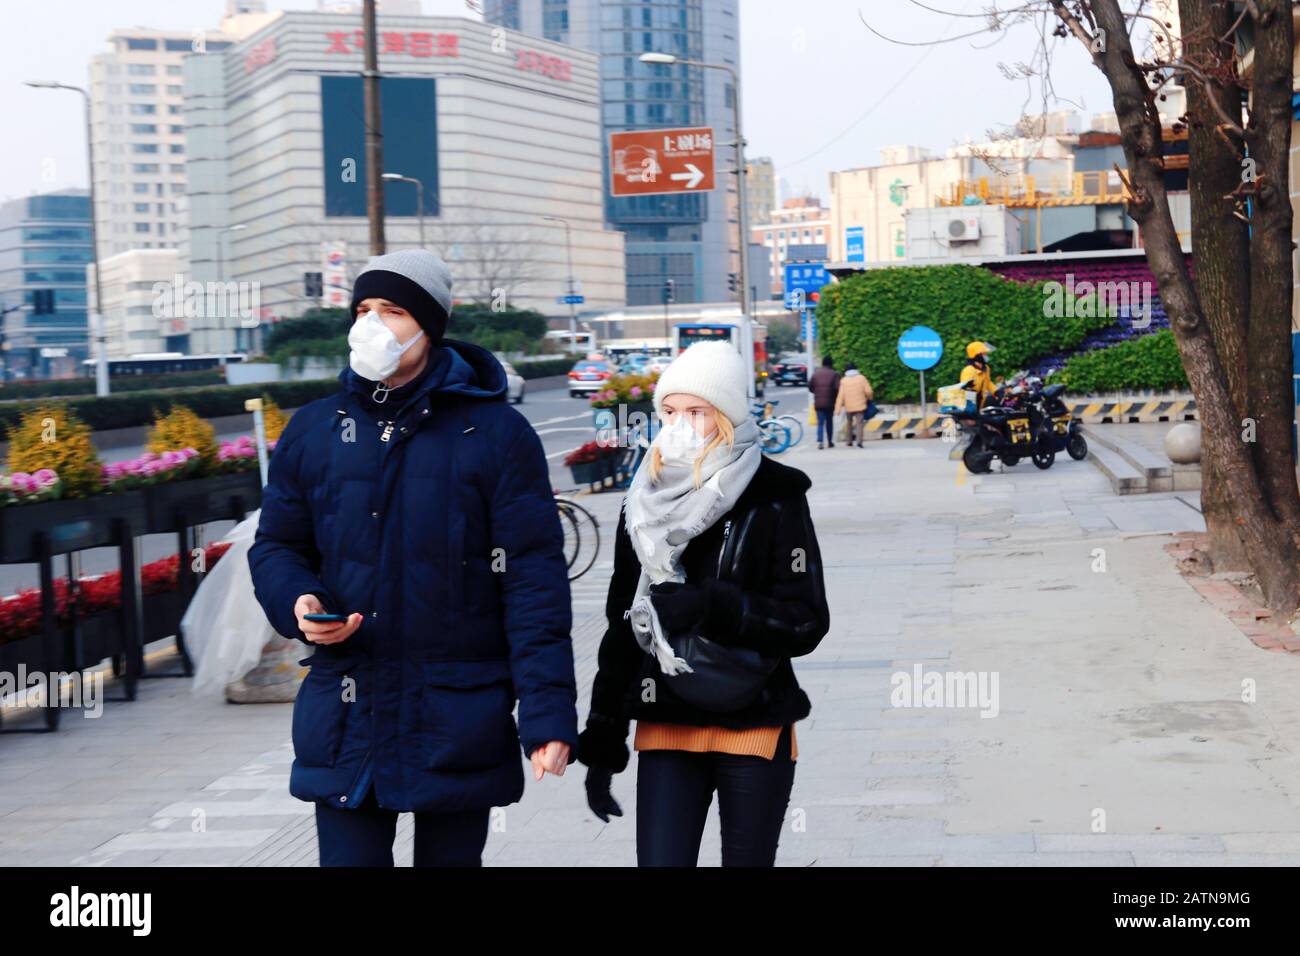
[579,342,829,866]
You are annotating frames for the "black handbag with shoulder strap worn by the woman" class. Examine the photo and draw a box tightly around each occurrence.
[664,509,783,714]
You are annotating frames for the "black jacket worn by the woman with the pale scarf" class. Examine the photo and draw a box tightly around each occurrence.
[579,457,831,770]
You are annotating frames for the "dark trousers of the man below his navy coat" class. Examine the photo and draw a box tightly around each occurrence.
[316,787,490,866]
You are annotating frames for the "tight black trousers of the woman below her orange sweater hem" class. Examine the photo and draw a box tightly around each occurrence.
[637,726,794,866]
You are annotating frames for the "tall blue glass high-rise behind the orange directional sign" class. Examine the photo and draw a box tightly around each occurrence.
[484,0,761,306]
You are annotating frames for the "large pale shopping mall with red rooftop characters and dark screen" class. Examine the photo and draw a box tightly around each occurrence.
[178,12,625,352]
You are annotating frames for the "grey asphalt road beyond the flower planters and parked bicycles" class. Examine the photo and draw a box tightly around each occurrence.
[0,388,807,596]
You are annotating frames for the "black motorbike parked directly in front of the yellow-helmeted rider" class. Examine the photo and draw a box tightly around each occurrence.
[953,376,1056,475]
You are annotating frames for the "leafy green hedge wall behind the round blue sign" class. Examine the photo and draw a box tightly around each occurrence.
[816,265,1115,402]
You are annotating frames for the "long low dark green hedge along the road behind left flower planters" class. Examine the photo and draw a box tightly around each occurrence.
[0,378,339,436]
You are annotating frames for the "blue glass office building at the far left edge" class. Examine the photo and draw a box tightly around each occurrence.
[0,189,91,381]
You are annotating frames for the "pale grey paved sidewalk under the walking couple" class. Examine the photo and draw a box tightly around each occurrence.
[0,441,1300,866]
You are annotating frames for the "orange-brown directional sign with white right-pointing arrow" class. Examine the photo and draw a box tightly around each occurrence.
[610,126,714,196]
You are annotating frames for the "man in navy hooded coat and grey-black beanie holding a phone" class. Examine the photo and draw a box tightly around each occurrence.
[248,250,577,866]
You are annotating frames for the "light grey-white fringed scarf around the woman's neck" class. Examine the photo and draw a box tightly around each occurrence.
[623,419,763,675]
